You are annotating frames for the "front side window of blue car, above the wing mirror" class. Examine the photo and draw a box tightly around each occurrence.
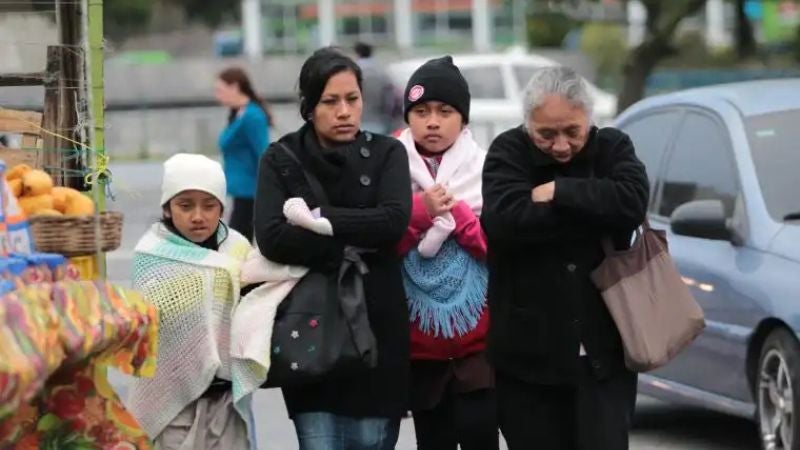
[658,112,738,217]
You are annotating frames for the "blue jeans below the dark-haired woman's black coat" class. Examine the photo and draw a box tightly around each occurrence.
[294,412,400,450]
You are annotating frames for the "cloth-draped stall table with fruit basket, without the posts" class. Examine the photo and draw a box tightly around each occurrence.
[0,154,158,450]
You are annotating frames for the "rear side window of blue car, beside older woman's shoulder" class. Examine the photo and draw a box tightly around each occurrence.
[622,110,681,201]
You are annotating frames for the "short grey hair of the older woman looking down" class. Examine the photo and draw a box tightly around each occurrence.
[523,66,594,126]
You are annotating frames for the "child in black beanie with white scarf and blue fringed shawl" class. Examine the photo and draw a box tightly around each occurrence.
[399,56,499,450]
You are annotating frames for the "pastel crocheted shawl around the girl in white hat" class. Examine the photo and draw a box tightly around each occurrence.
[127,223,255,447]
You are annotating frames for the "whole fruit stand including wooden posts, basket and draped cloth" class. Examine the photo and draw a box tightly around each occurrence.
[0,0,158,450]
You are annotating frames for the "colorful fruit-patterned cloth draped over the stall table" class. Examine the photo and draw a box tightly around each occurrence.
[0,281,158,450]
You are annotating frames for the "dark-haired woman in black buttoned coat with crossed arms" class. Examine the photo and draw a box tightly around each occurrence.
[255,48,411,450]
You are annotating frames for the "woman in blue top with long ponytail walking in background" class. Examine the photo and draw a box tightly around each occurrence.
[214,67,273,240]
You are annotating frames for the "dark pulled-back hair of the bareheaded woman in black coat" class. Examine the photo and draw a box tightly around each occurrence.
[298,47,362,121]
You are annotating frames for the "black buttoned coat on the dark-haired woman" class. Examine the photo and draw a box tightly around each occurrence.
[253,124,411,417]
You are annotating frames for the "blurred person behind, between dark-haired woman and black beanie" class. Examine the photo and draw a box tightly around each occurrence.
[354,42,398,134]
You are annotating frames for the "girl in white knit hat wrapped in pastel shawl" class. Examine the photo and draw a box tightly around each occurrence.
[128,154,255,450]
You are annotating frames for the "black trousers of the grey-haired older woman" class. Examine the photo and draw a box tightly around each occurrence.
[497,361,637,450]
